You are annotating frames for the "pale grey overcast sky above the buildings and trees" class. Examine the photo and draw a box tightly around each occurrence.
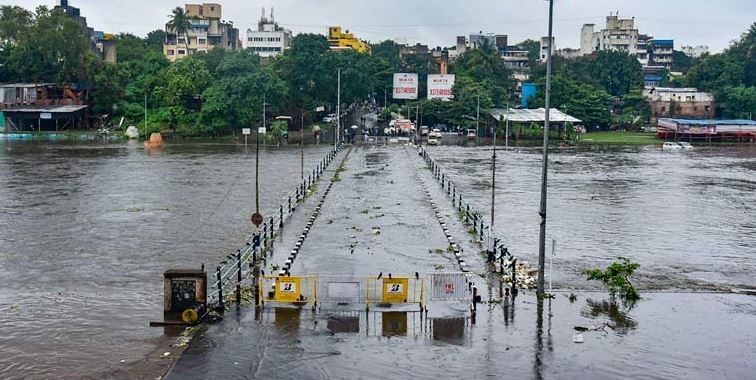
[5,0,756,52]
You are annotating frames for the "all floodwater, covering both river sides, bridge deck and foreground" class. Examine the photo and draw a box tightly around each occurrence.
[0,135,756,379]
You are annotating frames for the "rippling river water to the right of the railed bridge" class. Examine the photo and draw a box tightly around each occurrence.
[428,145,756,291]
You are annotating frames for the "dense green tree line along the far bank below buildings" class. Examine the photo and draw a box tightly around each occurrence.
[0,6,756,135]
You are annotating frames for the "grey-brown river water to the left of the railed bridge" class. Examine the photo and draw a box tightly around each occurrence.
[0,140,328,378]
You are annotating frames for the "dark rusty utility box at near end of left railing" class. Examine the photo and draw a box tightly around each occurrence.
[163,269,207,323]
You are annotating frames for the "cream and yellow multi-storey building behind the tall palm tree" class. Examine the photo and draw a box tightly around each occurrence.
[163,3,240,61]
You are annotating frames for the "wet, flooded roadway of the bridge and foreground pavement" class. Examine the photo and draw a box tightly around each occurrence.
[168,146,756,379]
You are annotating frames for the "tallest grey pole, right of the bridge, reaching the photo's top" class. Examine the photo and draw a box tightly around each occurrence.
[536,0,554,297]
